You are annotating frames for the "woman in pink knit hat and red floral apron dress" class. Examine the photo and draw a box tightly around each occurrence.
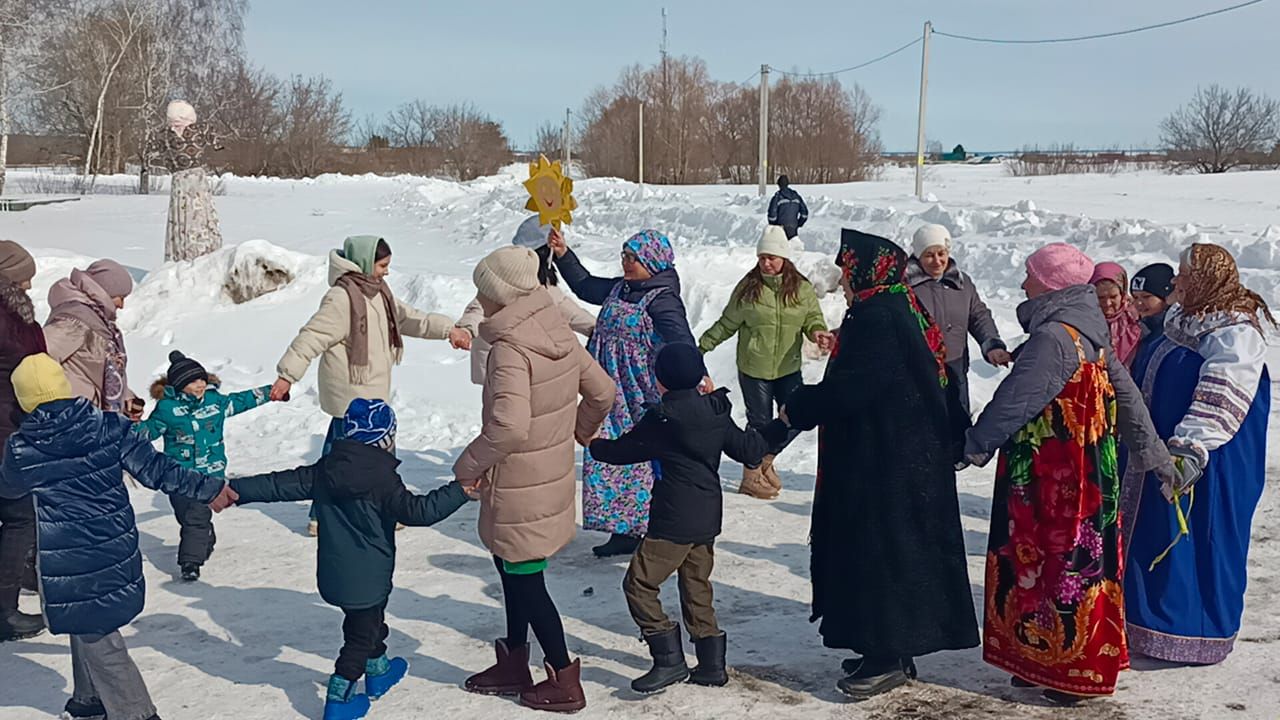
[965,243,1172,705]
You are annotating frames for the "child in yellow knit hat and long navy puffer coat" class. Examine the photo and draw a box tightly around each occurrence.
[0,354,230,720]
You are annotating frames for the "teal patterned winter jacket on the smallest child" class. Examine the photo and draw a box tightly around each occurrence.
[134,377,271,478]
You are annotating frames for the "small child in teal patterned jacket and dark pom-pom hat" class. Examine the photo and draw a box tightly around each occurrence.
[136,350,279,583]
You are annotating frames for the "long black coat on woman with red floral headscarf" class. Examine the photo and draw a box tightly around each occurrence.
[786,293,978,657]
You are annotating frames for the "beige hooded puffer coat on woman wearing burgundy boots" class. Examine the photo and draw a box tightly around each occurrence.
[453,288,614,562]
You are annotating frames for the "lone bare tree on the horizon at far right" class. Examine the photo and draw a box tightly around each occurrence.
[1160,85,1280,173]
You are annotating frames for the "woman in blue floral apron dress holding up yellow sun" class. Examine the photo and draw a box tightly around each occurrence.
[548,229,696,557]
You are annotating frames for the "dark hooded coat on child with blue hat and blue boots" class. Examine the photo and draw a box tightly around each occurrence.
[230,439,467,610]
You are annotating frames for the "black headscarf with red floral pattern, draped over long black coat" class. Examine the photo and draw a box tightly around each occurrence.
[836,231,947,387]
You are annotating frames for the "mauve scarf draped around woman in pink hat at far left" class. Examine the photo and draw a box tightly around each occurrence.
[49,270,128,413]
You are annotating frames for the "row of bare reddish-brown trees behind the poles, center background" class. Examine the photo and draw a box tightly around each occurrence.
[565,58,881,183]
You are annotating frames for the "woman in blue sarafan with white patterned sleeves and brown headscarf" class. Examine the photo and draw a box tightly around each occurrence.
[1121,243,1275,665]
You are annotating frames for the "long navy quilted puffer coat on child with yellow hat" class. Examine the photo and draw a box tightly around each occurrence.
[0,398,223,635]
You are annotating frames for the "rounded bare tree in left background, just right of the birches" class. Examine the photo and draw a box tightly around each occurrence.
[279,76,351,177]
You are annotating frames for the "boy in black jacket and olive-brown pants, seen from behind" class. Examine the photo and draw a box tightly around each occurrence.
[591,343,769,693]
